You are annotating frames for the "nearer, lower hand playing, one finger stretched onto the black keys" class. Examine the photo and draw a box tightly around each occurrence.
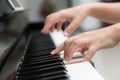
[51,27,119,61]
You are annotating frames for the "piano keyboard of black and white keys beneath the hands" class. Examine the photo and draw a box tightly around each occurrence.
[15,31,104,80]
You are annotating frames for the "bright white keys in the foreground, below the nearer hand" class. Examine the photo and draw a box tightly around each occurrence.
[66,62,105,80]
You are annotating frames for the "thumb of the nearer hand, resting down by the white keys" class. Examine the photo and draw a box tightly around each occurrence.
[83,46,98,61]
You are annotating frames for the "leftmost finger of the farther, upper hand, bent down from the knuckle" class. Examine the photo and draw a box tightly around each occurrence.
[41,10,73,34]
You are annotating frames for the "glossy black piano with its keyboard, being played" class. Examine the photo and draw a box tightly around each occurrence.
[0,0,104,80]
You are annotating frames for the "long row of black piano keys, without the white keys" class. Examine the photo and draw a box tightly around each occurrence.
[15,31,69,80]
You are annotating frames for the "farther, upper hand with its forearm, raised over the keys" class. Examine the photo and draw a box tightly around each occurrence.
[41,2,120,36]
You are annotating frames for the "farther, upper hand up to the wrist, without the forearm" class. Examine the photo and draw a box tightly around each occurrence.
[41,4,90,36]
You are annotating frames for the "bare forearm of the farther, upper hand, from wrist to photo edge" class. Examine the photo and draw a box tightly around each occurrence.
[87,2,120,23]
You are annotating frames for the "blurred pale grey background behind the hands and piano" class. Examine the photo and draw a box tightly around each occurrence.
[2,0,120,80]
